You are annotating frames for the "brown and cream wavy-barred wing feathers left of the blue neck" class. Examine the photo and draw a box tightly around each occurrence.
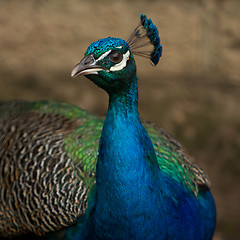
[0,113,87,237]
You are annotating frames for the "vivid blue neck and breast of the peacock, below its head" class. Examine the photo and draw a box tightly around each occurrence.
[81,75,214,240]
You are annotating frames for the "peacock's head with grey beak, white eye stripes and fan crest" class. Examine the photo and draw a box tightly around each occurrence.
[71,14,162,92]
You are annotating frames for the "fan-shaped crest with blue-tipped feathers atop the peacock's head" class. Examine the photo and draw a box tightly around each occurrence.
[127,14,162,65]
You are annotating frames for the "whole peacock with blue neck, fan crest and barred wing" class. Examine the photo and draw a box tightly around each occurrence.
[0,14,216,240]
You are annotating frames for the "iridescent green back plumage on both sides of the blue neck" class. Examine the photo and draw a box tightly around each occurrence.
[31,101,210,196]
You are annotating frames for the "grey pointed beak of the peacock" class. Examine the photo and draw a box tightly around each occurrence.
[71,55,104,77]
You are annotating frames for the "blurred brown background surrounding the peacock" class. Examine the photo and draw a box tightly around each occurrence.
[0,0,240,240]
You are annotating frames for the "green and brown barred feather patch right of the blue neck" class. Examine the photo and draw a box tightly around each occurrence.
[144,123,211,197]
